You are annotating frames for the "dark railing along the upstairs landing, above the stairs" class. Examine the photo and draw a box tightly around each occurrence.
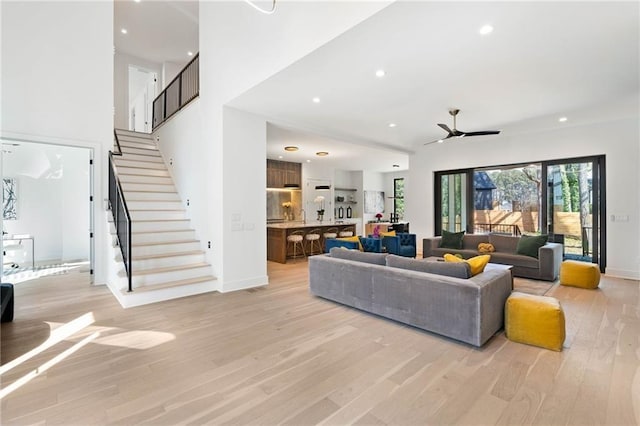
[153,54,200,130]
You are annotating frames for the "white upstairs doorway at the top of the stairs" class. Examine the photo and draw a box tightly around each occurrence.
[129,65,158,133]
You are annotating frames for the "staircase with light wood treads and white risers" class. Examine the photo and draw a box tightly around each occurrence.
[109,129,217,307]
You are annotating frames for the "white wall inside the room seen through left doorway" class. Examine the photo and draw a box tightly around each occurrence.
[2,143,89,262]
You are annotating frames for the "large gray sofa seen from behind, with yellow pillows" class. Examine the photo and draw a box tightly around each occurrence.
[309,248,512,347]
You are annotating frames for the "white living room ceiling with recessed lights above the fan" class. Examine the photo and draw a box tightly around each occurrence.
[231,2,639,166]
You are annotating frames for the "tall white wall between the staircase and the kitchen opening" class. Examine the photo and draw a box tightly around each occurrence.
[196,2,388,291]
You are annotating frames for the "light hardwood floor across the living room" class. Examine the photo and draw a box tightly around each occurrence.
[0,260,640,425]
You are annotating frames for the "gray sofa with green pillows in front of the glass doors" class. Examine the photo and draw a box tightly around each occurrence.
[422,234,563,281]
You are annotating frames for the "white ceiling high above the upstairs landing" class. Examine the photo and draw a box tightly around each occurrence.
[113,0,199,64]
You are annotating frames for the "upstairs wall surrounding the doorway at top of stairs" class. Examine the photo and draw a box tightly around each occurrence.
[112,51,162,129]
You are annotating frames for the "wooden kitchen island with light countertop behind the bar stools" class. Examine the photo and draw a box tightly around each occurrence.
[267,221,356,263]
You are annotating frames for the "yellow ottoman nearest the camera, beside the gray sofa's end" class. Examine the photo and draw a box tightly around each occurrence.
[504,292,565,351]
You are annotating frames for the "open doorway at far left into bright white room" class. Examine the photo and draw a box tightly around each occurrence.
[0,140,94,283]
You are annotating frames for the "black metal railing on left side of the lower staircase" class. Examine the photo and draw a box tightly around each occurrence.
[109,132,133,291]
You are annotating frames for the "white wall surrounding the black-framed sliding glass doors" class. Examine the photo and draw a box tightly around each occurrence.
[406,116,640,279]
